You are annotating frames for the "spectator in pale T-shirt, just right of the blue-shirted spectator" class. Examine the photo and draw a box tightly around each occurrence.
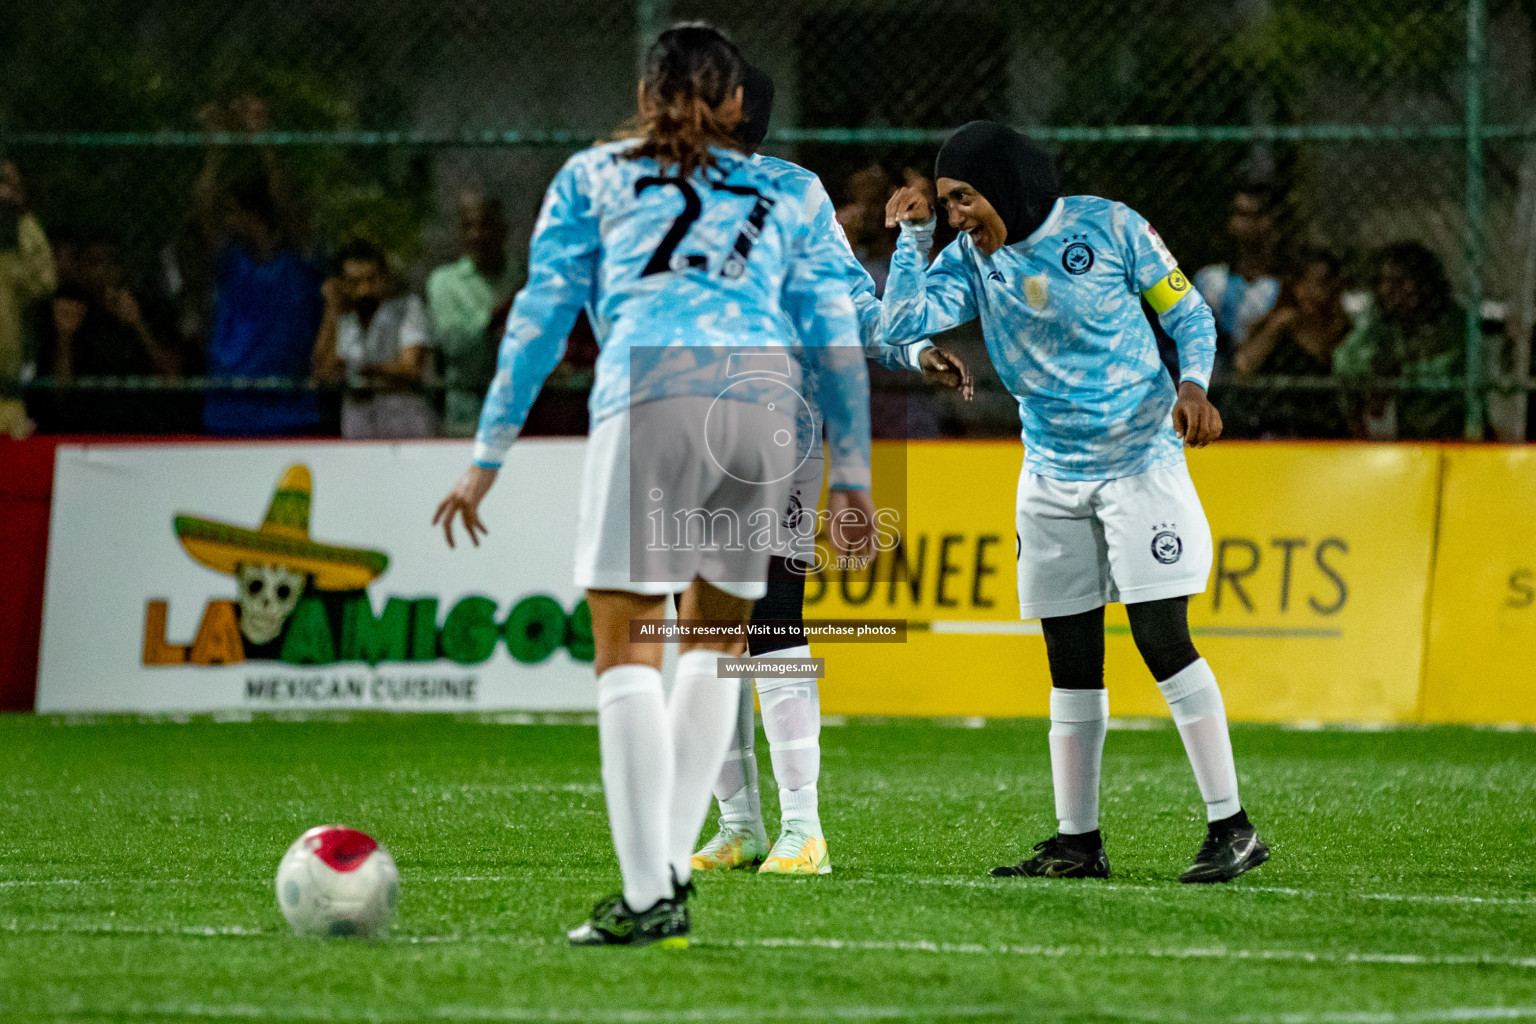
[313,239,438,439]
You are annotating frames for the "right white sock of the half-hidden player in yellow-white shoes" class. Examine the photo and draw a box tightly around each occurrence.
[757,646,822,835]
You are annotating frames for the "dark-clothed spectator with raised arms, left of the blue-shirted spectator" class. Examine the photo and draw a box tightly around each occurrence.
[35,238,180,433]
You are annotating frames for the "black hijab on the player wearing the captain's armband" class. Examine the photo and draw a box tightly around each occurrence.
[934,121,1061,246]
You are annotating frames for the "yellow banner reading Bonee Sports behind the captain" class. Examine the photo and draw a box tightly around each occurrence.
[806,442,1443,722]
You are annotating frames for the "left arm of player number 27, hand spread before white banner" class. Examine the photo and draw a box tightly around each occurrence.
[432,155,601,548]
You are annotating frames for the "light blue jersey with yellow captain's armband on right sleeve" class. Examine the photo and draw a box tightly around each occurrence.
[882,195,1217,481]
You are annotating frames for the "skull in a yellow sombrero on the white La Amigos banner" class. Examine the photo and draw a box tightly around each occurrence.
[175,465,389,645]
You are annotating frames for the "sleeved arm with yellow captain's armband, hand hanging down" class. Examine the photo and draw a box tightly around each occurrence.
[1115,204,1221,448]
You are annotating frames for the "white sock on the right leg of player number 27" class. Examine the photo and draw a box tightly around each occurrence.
[667,651,742,883]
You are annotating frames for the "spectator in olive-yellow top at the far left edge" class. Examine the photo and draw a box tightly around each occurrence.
[0,160,55,438]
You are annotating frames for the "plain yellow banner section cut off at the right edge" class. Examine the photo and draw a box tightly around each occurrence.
[1422,447,1536,725]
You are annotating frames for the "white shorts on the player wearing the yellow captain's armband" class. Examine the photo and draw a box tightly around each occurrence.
[1015,465,1212,619]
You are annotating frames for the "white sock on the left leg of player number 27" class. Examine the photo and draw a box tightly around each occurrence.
[598,665,673,910]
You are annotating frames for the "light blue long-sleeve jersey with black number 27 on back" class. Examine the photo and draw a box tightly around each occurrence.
[475,140,869,488]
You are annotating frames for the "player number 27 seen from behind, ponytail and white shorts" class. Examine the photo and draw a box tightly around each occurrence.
[433,23,872,947]
